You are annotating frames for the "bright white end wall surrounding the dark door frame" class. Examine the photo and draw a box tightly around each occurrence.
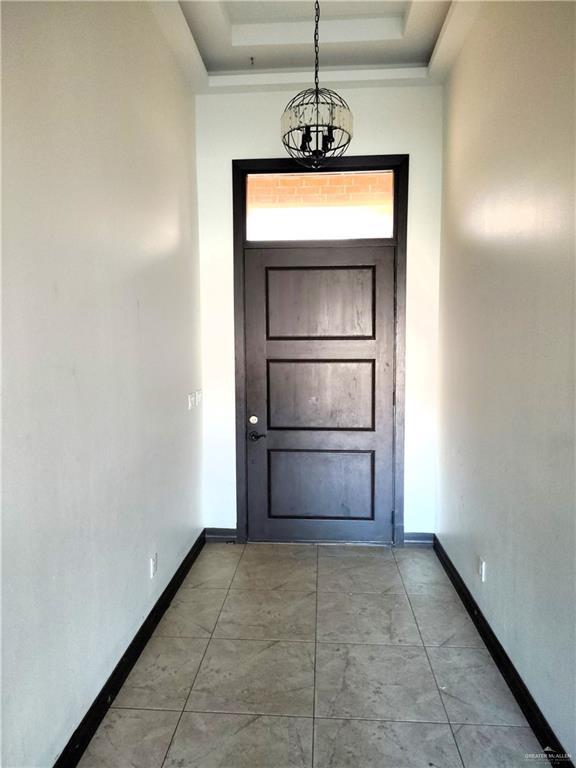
[196,87,442,532]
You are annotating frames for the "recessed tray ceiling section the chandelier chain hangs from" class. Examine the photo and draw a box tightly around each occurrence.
[180,0,450,73]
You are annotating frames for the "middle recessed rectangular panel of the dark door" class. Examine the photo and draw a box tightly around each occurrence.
[268,360,375,430]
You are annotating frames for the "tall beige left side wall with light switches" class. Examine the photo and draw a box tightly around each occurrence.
[2,2,205,768]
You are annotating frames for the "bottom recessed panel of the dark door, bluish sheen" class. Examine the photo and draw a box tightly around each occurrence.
[268,450,374,520]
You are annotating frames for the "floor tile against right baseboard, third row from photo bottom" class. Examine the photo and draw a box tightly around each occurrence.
[410,595,484,648]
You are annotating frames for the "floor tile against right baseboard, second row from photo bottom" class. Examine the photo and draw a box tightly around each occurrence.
[428,648,526,725]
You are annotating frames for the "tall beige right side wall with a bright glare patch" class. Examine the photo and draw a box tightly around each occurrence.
[438,2,576,754]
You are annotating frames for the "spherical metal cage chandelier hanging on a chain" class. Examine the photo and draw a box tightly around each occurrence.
[280,0,352,169]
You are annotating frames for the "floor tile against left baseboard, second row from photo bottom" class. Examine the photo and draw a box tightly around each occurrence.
[113,637,208,711]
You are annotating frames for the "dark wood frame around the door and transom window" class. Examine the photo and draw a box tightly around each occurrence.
[232,155,409,546]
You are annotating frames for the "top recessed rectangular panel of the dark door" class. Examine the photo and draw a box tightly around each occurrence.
[266,267,375,339]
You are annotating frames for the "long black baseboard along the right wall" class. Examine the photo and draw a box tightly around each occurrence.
[434,536,574,768]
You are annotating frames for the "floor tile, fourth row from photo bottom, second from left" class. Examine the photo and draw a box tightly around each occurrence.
[232,554,316,592]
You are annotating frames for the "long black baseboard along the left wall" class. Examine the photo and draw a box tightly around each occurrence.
[54,531,206,768]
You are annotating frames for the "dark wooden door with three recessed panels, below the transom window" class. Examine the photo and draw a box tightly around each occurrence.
[244,242,395,542]
